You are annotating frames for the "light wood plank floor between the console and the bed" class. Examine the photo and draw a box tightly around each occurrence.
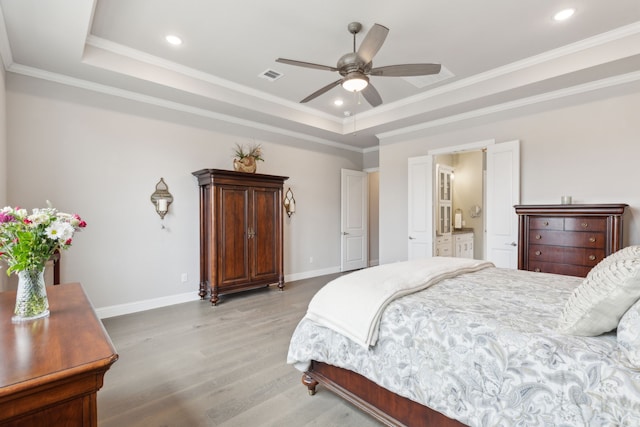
[98,275,381,427]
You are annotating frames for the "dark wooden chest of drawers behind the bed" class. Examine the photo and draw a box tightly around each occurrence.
[515,204,628,277]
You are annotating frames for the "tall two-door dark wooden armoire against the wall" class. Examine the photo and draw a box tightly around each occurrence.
[193,169,288,305]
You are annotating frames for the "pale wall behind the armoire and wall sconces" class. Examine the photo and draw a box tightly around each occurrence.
[5,74,362,314]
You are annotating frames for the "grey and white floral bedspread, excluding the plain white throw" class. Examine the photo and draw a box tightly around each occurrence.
[287,267,640,427]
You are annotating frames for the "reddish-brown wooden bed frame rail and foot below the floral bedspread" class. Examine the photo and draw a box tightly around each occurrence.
[302,360,465,427]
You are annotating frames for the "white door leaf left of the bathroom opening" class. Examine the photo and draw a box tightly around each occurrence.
[407,156,434,260]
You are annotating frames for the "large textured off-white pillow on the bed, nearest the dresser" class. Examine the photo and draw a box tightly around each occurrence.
[557,246,640,336]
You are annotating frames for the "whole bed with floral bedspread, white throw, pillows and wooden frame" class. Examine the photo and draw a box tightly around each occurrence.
[287,251,640,427]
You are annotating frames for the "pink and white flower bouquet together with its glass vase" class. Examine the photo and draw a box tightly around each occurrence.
[0,201,87,322]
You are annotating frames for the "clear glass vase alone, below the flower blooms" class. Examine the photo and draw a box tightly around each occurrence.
[11,269,49,323]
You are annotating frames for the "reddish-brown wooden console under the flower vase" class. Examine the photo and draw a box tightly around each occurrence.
[0,283,118,427]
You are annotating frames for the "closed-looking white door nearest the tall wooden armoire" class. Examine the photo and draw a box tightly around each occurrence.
[340,169,369,271]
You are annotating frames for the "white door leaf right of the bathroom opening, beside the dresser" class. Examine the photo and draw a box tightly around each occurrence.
[485,141,520,268]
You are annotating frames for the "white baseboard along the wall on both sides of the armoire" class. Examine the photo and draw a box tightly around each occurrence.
[96,267,340,319]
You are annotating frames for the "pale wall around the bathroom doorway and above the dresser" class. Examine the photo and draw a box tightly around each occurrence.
[380,90,640,264]
